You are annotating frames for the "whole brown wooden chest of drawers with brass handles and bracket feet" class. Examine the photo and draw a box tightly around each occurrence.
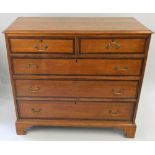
[5,18,152,137]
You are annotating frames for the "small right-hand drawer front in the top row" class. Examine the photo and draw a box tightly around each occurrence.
[80,39,145,53]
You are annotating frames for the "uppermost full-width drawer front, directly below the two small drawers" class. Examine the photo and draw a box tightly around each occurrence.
[13,59,142,75]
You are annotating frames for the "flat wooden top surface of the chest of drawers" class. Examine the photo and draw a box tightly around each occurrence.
[5,17,152,34]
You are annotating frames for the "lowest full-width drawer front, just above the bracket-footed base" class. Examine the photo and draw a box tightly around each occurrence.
[18,101,134,120]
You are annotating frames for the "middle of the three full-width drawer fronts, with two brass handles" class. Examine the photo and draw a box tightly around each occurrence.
[15,80,137,98]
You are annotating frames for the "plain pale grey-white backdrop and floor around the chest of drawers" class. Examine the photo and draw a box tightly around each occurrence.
[0,13,155,140]
